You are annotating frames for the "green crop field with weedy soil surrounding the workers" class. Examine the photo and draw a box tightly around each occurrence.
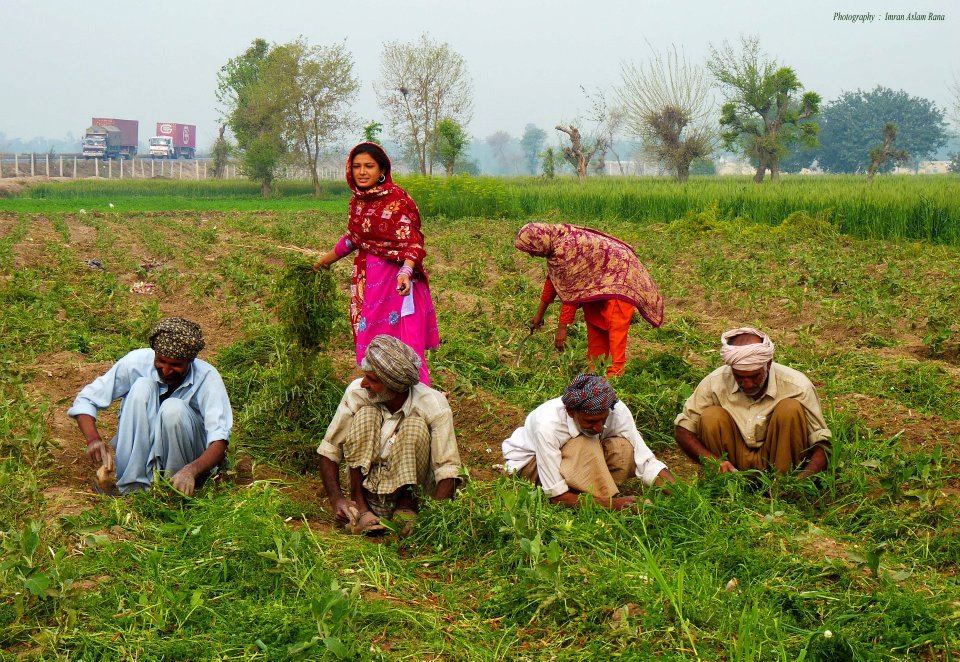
[0,176,960,661]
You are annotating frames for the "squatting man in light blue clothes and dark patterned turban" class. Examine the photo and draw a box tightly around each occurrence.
[67,317,233,496]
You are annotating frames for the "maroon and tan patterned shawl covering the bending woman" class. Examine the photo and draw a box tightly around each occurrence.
[516,223,663,327]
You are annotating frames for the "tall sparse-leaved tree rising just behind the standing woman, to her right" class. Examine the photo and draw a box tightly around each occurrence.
[374,34,473,175]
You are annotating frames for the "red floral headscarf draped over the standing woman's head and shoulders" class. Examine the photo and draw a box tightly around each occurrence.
[347,143,426,273]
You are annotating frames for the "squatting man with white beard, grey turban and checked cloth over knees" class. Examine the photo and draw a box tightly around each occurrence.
[317,335,460,535]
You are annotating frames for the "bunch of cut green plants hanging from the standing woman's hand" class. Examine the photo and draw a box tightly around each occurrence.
[274,258,344,349]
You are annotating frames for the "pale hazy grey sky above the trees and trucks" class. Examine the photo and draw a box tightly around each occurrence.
[0,0,960,149]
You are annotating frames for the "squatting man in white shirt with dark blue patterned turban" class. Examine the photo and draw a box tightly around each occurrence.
[503,374,674,510]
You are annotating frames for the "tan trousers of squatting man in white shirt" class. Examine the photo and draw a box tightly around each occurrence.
[517,435,637,501]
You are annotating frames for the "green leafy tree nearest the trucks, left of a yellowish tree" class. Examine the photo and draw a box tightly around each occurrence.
[217,39,286,196]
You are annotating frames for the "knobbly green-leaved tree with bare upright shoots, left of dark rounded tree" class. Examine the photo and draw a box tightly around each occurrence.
[707,37,820,184]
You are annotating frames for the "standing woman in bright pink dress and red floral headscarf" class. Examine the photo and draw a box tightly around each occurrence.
[313,142,440,386]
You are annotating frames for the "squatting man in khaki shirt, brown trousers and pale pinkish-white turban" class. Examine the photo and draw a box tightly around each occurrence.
[674,327,831,478]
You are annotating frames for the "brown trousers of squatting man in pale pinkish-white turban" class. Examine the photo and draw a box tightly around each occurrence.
[700,398,810,474]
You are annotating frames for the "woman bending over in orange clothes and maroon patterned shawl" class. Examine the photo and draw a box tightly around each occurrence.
[516,223,663,377]
